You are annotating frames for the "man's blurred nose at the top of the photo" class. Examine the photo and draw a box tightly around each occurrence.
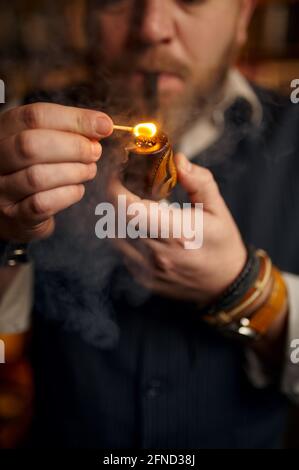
[138,0,175,45]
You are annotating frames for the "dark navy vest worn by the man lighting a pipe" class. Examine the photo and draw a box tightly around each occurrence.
[26,84,299,449]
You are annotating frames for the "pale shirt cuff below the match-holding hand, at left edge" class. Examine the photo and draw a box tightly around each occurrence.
[0,263,33,334]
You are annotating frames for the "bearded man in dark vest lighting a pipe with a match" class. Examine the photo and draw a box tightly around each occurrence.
[0,0,299,449]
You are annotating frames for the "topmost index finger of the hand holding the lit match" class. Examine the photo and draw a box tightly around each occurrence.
[0,103,113,140]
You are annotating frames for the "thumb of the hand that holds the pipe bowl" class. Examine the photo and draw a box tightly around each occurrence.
[175,153,224,213]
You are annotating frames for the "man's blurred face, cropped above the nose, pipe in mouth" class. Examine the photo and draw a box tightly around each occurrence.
[89,0,254,132]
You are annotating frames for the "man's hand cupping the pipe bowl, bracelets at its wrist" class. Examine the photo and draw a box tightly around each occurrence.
[110,155,246,305]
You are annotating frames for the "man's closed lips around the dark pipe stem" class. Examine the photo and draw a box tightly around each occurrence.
[131,71,184,93]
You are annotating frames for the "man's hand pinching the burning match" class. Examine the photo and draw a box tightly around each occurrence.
[0,103,113,242]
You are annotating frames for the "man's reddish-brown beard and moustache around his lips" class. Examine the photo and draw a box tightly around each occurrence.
[89,43,235,143]
